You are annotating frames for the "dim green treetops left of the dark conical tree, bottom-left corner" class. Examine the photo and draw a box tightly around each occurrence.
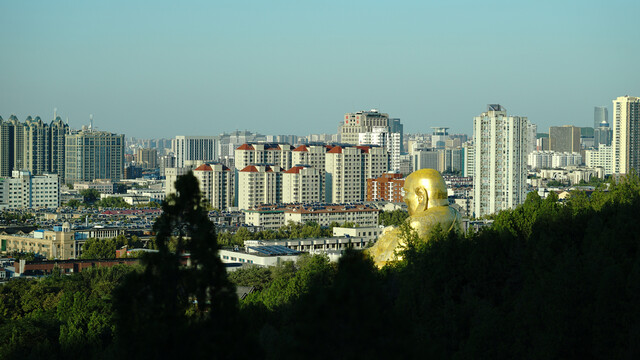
[0,265,137,359]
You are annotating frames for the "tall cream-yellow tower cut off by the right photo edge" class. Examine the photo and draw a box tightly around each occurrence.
[611,95,640,174]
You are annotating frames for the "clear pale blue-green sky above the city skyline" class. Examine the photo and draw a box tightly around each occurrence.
[0,0,640,138]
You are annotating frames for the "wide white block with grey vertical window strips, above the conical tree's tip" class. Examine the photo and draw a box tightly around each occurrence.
[171,136,217,167]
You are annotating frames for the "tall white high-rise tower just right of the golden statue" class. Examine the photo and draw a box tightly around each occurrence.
[473,104,528,217]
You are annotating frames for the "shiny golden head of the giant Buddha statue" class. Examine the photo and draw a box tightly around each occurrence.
[404,169,449,216]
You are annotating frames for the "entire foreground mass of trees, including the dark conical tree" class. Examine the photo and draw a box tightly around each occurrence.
[0,176,640,359]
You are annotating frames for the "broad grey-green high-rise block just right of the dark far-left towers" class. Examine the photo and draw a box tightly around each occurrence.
[65,129,124,183]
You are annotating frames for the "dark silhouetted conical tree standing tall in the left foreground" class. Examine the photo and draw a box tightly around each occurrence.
[116,172,240,359]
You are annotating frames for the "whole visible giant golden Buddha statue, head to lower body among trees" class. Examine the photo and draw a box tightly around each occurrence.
[366,169,462,268]
